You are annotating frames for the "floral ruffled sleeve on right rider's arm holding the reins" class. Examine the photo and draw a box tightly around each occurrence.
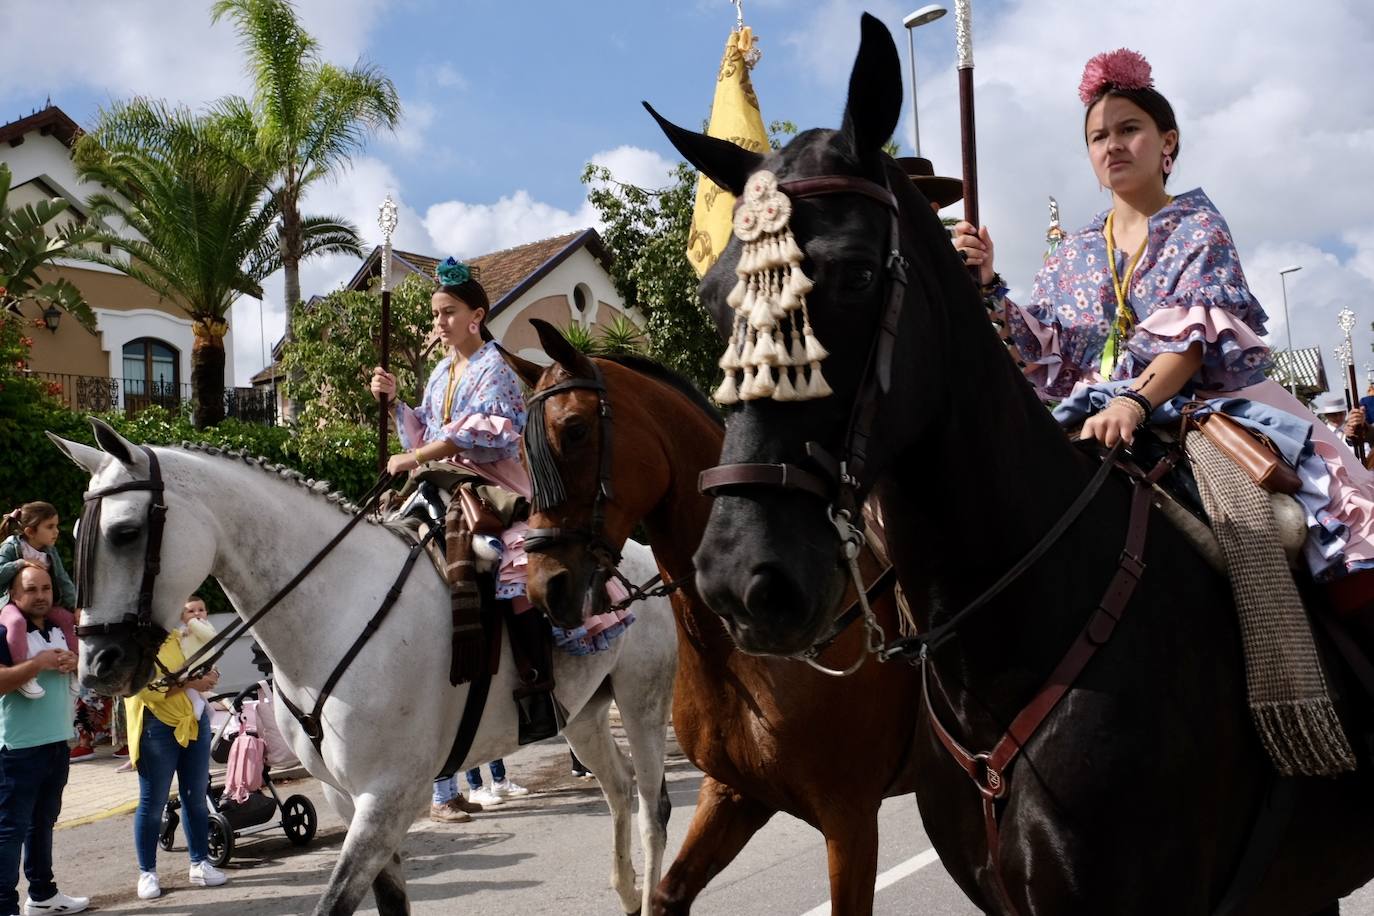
[1127,218,1272,391]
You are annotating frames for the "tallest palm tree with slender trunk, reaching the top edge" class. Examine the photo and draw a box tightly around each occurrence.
[212,0,401,335]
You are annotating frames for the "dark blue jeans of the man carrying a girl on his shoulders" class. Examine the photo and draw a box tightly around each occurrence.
[0,741,71,913]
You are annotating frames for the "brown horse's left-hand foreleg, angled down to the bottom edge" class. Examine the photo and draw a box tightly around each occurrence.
[650,776,776,916]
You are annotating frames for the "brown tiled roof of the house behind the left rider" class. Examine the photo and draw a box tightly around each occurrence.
[348,229,611,316]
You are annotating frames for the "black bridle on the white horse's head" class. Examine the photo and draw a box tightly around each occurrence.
[76,445,168,678]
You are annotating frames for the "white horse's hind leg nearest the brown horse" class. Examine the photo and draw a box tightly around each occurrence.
[612,673,673,912]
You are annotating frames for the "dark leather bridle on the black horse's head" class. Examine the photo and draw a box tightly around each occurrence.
[698,174,908,674]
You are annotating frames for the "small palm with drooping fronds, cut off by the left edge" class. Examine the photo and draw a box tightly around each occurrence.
[0,162,95,330]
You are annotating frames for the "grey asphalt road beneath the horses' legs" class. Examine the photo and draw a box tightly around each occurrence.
[37,739,1374,916]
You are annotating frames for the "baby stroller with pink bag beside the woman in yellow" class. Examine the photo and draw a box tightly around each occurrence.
[159,681,319,868]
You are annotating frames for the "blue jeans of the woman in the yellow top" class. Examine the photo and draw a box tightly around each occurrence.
[133,710,212,872]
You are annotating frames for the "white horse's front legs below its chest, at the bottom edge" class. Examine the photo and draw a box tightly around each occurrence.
[312,787,427,916]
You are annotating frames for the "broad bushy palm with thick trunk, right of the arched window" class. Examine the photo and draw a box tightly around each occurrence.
[76,99,360,427]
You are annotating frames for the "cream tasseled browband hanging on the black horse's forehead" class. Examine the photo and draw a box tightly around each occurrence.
[716,172,831,404]
